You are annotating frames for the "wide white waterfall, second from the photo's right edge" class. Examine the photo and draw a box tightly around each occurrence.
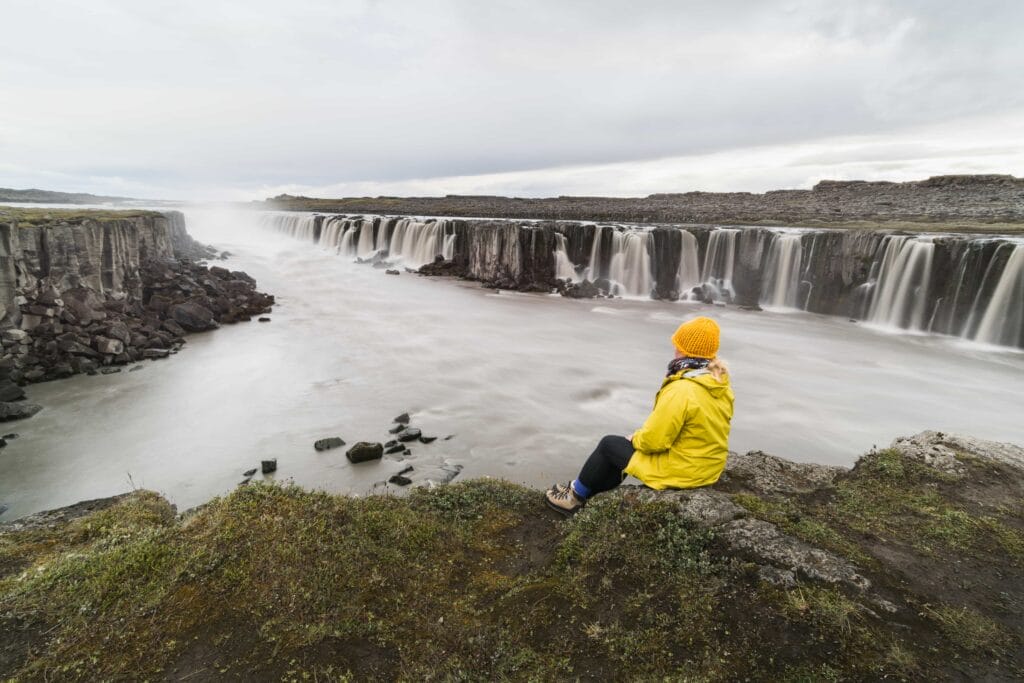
[867,237,935,330]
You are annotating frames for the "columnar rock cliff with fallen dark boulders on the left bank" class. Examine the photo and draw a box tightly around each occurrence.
[0,210,274,420]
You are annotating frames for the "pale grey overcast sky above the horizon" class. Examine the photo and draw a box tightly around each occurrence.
[0,0,1024,199]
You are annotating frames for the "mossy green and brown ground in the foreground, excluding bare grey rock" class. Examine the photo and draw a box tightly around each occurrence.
[0,453,1024,681]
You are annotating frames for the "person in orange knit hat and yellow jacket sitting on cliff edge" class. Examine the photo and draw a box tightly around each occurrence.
[545,317,733,515]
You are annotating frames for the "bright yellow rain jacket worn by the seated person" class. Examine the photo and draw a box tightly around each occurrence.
[626,370,733,489]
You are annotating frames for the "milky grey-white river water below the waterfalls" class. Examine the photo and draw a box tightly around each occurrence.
[0,211,1024,520]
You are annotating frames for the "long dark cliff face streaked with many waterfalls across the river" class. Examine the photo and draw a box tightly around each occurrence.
[263,213,1024,347]
